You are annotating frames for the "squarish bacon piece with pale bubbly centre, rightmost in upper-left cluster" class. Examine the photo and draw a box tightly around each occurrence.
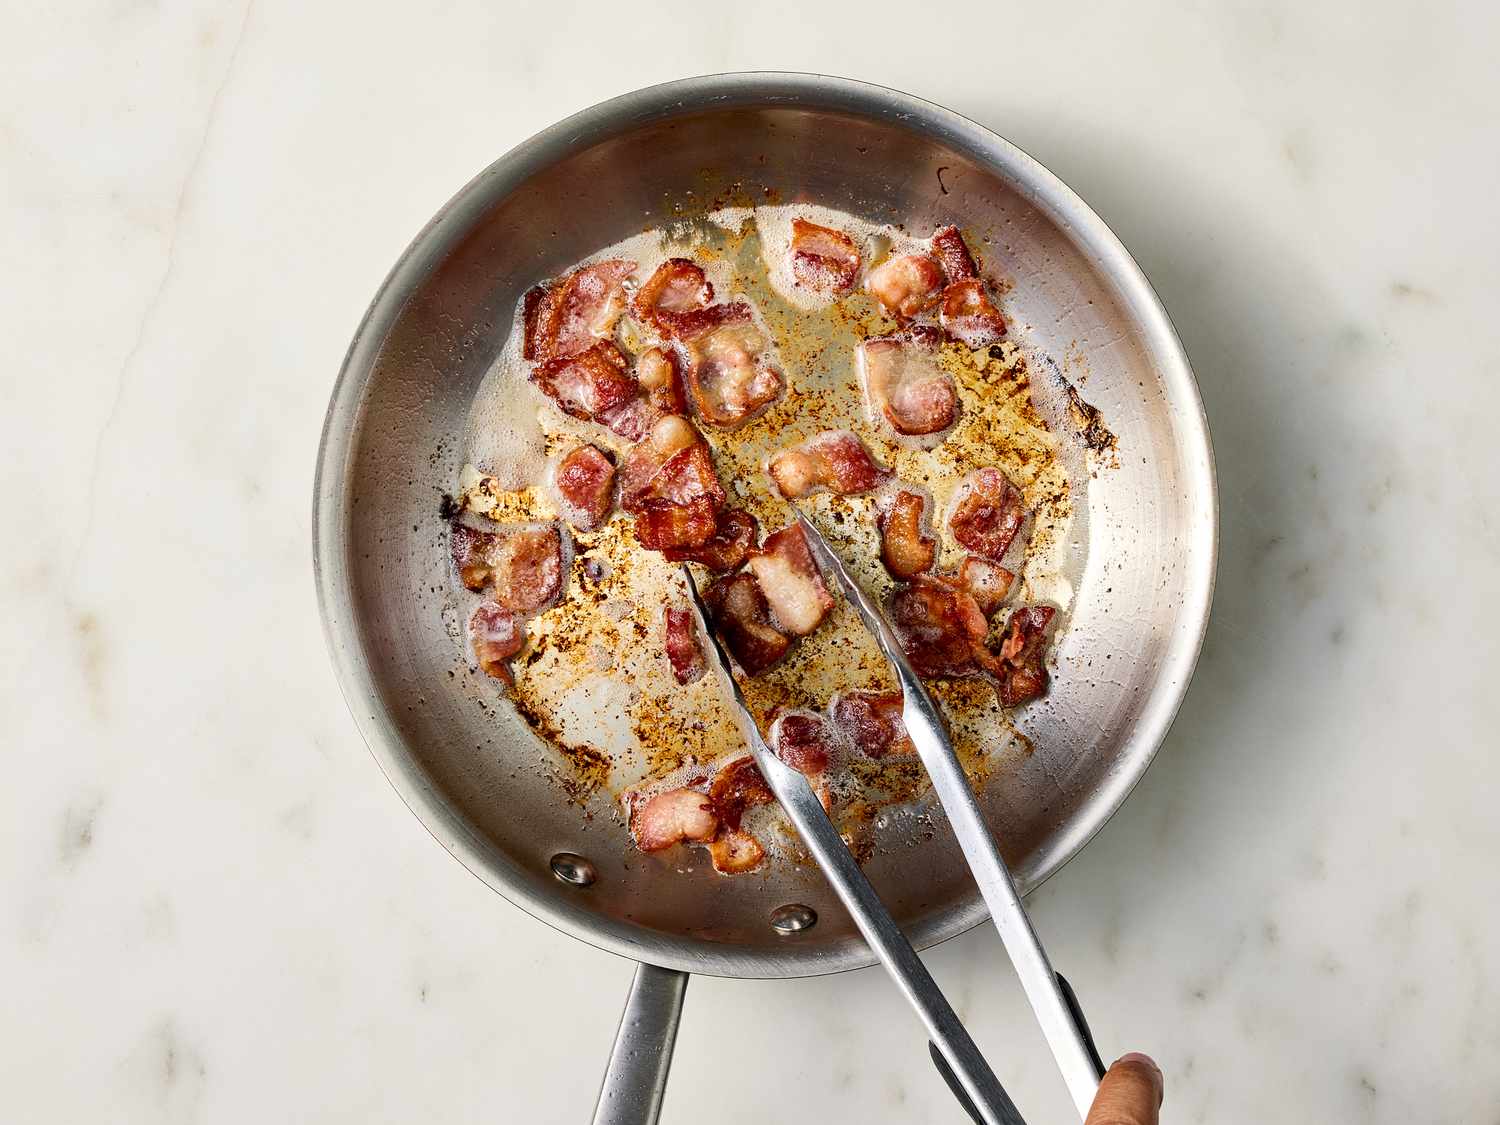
[677,303,782,429]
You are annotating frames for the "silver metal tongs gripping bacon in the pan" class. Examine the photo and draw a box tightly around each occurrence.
[683,512,1104,1125]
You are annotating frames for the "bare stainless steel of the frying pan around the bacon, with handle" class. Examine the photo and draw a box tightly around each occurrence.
[314,74,1217,1121]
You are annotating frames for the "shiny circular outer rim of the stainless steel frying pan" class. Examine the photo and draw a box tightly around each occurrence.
[312,71,1218,978]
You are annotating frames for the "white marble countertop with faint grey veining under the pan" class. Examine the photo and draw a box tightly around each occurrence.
[0,0,1500,1125]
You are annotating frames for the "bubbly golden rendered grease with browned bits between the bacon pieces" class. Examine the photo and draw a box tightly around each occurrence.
[455,206,1107,861]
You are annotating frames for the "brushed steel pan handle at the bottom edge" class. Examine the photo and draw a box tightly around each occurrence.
[594,962,687,1125]
